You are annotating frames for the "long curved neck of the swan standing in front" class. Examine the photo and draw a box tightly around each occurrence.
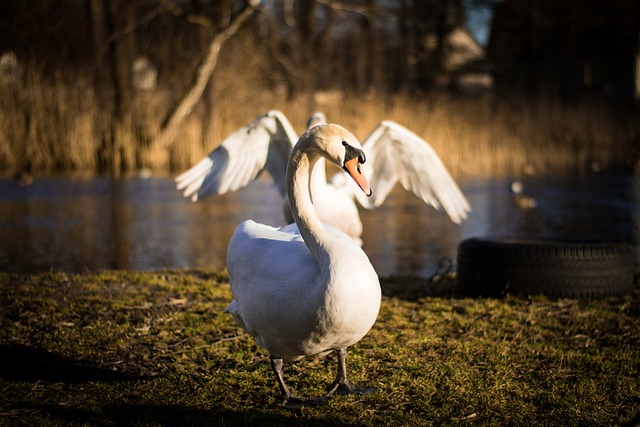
[287,144,332,262]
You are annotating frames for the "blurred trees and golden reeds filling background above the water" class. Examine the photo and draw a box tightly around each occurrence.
[0,0,640,176]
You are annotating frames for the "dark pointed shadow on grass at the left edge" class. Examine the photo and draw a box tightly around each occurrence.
[0,344,139,384]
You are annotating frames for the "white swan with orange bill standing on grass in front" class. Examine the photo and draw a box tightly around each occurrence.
[227,124,381,405]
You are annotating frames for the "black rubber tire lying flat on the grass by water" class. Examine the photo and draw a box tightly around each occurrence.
[457,237,634,298]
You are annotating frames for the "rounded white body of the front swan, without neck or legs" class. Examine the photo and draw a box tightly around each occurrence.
[227,220,380,362]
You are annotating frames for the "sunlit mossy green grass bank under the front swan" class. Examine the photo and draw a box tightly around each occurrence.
[0,270,640,426]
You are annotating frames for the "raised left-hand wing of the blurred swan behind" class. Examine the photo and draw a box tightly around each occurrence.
[175,110,298,202]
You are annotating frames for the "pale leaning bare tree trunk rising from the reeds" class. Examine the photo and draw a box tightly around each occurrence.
[153,0,259,147]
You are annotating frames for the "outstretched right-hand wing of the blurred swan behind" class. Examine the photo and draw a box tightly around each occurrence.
[355,120,471,224]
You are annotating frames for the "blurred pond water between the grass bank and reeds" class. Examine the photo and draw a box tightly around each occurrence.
[0,175,640,277]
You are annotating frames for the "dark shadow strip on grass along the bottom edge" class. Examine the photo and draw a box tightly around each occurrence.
[3,402,356,427]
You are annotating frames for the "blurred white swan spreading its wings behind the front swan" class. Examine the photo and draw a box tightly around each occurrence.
[176,110,471,243]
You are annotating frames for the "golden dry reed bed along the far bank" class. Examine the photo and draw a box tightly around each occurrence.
[0,66,640,177]
